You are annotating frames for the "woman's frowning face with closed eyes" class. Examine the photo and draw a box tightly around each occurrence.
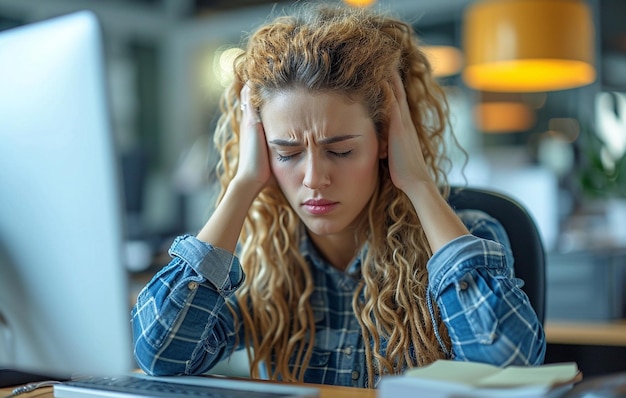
[261,89,386,236]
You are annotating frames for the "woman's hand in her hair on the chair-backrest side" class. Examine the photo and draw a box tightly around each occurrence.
[388,72,433,193]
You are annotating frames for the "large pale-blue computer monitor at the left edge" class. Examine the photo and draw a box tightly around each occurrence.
[0,11,133,382]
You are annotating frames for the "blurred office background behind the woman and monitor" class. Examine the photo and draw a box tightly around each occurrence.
[0,0,626,373]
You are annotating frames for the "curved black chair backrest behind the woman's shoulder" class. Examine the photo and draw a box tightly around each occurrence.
[448,187,546,324]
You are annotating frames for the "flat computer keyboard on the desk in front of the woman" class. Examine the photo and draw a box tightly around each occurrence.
[54,375,319,398]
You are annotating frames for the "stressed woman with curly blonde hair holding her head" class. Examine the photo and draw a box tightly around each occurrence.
[133,5,545,387]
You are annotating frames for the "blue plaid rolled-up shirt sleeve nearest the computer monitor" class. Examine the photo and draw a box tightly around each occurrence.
[131,235,244,375]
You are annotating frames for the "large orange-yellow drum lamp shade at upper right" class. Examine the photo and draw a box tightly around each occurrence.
[462,0,596,92]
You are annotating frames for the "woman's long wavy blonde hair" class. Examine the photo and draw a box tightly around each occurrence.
[214,4,450,386]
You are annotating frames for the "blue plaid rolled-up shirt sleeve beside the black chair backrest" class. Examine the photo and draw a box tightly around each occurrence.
[428,211,546,366]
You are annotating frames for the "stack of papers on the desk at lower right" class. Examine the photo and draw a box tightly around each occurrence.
[378,360,582,398]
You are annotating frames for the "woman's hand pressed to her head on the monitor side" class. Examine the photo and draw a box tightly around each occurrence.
[233,84,272,193]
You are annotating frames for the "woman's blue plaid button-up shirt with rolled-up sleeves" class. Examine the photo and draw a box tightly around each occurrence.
[132,211,546,387]
